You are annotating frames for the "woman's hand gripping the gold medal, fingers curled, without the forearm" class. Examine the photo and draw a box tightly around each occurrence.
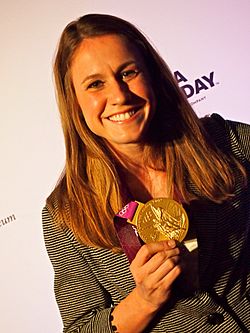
[130,240,181,311]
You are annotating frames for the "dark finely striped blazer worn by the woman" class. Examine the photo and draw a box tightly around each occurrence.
[43,115,250,333]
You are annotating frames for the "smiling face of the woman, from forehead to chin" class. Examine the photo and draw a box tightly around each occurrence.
[71,35,155,150]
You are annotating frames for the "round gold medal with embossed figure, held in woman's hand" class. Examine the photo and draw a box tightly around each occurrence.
[128,198,189,243]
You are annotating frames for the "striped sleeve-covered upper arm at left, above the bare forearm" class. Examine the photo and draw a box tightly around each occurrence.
[43,208,111,333]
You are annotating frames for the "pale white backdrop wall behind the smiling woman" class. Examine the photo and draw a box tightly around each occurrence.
[0,0,250,333]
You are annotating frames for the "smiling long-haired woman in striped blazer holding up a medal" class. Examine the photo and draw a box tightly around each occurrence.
[43,14,250,333]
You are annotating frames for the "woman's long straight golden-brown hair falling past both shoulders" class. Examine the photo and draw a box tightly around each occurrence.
[47,14,246,250]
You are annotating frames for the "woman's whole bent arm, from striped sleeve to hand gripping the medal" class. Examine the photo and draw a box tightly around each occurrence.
[43,208,180,333]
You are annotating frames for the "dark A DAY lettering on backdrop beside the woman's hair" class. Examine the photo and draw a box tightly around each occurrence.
[174,71,219,105]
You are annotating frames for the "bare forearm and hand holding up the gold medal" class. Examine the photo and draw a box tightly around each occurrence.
[109,240,181,333]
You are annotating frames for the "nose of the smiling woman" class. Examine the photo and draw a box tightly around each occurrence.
[109,79,131,105]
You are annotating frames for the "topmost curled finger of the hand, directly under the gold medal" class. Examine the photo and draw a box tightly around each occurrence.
[133,240,176,266]
